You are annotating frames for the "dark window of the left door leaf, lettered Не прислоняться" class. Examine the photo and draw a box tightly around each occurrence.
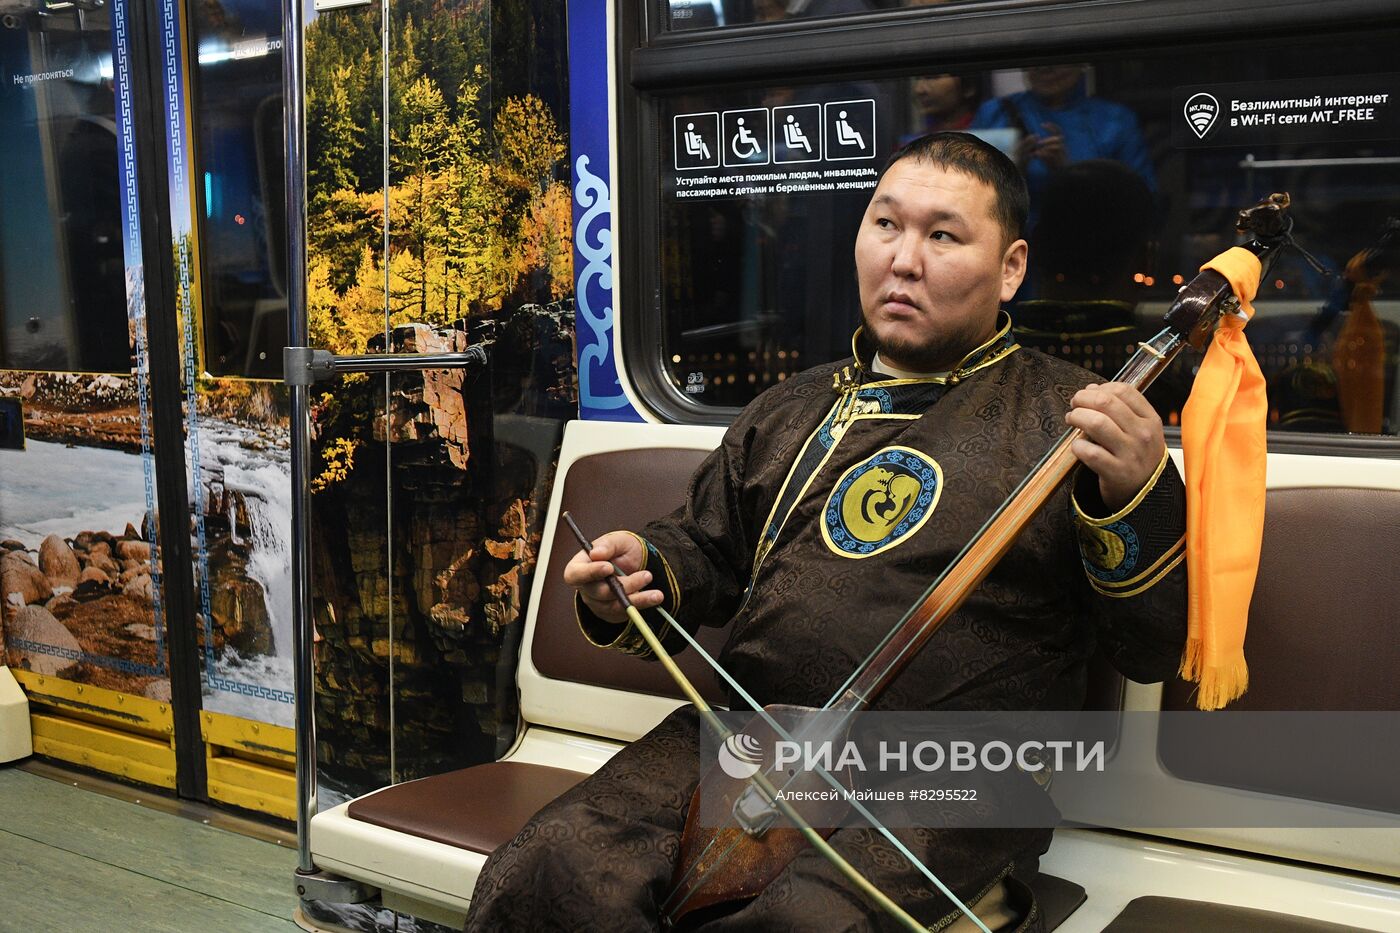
[0,4,132,373]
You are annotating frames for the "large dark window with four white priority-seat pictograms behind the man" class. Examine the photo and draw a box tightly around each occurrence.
[641,34,1400,434]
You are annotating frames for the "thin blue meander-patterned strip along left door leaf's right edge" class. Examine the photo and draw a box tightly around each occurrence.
[110,0,167,675]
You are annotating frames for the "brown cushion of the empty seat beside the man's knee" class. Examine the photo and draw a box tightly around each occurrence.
[347,761,587,855]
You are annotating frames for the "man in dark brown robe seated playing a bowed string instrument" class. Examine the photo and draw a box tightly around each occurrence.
[468,133,1186,932]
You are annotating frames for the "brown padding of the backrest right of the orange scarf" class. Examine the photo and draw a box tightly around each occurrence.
[1158,488,1400,811]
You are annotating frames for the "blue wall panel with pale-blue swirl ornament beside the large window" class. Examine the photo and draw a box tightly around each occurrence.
[568,0,643,422]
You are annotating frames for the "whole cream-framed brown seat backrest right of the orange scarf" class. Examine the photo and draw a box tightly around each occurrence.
[1056,451,1400,877]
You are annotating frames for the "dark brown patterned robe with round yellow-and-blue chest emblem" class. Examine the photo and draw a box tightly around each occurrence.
[468,315,1186,932]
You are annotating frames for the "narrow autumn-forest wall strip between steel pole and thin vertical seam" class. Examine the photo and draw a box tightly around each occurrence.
[304,3,402,801]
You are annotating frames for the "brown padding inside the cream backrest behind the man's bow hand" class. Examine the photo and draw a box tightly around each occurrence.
[531,447,729,703]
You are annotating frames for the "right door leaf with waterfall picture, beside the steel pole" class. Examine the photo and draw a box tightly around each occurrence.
[180,0,294,817]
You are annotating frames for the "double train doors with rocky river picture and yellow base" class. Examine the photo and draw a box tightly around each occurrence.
[0,3,302,818]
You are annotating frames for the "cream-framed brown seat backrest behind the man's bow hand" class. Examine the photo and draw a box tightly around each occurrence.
[517,422,728,741]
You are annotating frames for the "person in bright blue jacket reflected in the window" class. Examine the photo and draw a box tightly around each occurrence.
[972,64,1156,198]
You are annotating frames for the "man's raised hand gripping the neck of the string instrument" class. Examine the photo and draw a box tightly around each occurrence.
[1064,382,1166,514]
